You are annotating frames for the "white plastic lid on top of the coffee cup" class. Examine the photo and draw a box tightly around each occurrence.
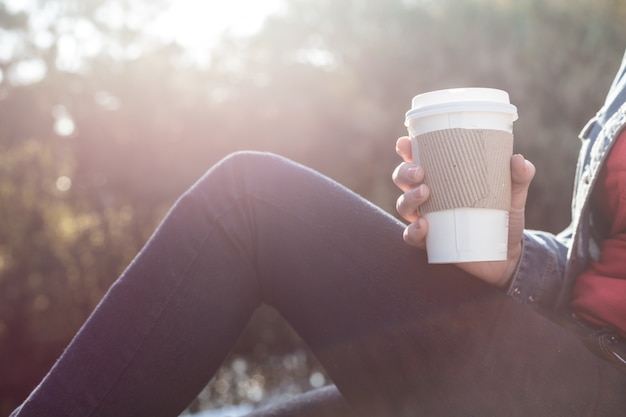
[406,88,517,120]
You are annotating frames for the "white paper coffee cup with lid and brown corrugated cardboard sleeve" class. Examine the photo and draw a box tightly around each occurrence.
[405,88,517,263]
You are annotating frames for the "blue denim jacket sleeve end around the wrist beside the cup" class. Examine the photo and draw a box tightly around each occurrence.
[508,229,571,309]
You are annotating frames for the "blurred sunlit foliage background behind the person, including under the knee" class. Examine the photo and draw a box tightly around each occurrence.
[0,0,626,416]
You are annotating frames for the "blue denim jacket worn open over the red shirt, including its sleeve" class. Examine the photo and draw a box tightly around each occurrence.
[509,48,626,316]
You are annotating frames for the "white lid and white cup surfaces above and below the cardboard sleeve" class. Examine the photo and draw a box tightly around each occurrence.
[405,88,517,263]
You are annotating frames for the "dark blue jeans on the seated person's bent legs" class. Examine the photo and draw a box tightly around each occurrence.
[9,153,626,417]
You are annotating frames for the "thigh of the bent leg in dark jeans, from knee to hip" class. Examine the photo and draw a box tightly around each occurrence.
[222,153,626,417]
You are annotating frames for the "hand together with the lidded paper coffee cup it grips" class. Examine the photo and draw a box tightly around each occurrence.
[394,88,534,285]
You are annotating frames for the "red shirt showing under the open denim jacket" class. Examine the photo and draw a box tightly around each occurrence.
[571,131,626,335]
